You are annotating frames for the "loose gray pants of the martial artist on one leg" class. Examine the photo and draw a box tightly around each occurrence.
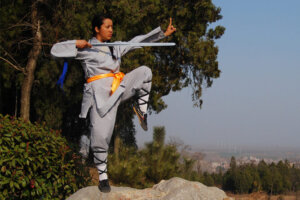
[90,66,152,179]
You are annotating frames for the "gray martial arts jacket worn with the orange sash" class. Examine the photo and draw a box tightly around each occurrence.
[51,27,165,118]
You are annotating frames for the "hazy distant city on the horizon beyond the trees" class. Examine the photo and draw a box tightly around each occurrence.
[188,147,300,173]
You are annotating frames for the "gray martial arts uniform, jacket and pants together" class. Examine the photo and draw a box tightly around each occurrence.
[51,27,165,180]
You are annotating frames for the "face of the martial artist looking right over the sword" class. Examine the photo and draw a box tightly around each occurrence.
[95,18,113,42]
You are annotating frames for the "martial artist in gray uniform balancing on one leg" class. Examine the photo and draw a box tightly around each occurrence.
[51,15,176,192]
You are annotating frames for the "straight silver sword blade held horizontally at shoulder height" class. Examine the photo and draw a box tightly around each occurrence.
[91,42,176,47]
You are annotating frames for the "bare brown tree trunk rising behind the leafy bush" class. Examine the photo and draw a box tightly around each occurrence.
[20,3,42,121]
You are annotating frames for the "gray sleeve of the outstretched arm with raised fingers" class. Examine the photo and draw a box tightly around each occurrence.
[118,27,166,56]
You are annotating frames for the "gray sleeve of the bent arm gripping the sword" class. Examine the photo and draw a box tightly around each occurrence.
[51,40,78,58]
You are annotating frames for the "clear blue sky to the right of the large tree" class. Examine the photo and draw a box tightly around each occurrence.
[135,0,300,149]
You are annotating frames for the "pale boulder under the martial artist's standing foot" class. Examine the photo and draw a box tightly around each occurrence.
[67,177,231,200]
